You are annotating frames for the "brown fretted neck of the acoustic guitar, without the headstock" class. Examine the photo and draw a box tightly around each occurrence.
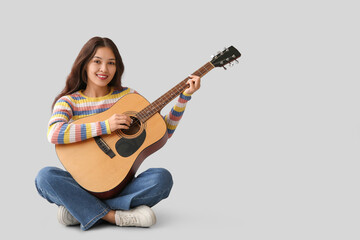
[136,62,214,122]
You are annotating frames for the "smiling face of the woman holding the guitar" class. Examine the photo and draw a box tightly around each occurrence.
[86,47,116,87]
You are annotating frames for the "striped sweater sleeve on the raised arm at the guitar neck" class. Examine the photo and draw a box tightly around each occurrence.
[164,93,191,138]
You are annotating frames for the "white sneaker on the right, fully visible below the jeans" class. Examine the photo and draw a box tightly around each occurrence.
[115,205,156,227]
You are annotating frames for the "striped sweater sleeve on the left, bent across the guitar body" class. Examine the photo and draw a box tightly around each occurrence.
[47,96,111,144]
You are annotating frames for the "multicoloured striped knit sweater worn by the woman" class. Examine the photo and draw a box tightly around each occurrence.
[47,87,191,144]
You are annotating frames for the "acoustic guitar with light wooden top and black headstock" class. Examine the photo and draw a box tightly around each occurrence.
[55,46,241,199]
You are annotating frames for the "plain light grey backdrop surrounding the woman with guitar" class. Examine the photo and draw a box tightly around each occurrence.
[0,0,360,239]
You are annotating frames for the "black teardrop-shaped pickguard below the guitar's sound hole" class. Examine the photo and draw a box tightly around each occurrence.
[115,129,146,157]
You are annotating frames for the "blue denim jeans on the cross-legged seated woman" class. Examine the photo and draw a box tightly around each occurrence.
[35,167,173,230]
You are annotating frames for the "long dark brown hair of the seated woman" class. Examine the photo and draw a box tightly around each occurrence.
[52,37,124,108]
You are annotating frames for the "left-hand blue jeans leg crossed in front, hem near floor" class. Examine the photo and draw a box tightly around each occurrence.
[35,167,110,230]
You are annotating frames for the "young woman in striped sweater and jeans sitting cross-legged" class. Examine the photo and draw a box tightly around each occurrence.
[35,37,200,230]
